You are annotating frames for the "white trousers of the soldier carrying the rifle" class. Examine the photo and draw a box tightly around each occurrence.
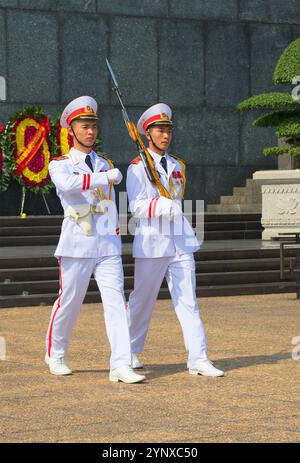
[127,254,207,367]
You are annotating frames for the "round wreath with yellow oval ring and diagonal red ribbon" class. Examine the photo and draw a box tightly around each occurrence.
[2,107,53,193]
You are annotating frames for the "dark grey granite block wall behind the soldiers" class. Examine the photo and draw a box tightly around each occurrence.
[0,0,300,214]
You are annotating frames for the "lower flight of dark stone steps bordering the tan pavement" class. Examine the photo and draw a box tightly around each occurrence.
[0,245,295,307]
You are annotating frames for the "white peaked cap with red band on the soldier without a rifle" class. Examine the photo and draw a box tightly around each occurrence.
[60,96,98,128]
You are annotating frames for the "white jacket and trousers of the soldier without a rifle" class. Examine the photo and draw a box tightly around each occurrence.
[46,97,131,370]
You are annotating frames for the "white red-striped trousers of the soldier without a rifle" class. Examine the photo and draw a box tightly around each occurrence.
[46,256,131,370]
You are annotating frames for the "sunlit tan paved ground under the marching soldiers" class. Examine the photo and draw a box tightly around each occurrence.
[0,294,300,443]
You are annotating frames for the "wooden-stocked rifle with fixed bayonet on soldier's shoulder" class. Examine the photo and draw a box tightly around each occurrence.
[106,58,170,198]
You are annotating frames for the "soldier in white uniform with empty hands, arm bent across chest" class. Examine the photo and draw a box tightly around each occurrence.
[45,96,145,383]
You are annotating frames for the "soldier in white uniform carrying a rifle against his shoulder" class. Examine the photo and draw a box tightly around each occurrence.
[127,103,224,376]
